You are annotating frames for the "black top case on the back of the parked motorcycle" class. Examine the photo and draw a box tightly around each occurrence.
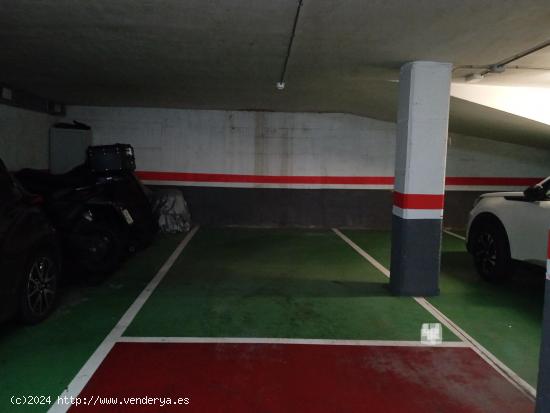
[86,143,136,172]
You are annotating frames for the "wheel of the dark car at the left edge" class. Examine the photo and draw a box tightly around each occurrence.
[19,249,60,324]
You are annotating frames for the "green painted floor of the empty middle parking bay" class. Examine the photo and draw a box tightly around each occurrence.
[125,229,456,341]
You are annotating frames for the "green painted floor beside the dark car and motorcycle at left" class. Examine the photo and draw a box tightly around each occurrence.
[0,236,182,413]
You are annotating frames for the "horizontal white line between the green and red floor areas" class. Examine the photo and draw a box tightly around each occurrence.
[117,336,470,347]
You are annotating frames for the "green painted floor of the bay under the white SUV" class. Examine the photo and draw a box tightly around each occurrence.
[345,231,544,388]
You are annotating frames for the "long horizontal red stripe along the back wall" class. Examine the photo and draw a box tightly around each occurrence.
[137,171,542,186]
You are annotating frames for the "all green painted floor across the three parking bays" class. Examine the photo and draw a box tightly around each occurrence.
[0,228,544,412]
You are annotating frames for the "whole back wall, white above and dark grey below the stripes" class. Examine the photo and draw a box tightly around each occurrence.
[62,107,550,228]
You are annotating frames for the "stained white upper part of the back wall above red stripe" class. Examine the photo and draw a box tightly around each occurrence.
[67,106,550,190]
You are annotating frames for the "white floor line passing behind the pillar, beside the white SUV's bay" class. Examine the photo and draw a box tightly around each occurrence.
[332,228,537,400]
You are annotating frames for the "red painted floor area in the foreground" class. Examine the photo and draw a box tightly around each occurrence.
[71,343,533,413]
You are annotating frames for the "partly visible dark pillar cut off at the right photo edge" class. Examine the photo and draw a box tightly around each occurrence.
[535,232,550,413]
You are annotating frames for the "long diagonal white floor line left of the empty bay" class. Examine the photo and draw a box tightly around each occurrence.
[48,226,199,413]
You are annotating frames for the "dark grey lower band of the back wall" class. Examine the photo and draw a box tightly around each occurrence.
[158,186,481,229]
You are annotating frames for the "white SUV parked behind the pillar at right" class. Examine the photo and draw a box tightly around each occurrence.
[467,177,550,281]
